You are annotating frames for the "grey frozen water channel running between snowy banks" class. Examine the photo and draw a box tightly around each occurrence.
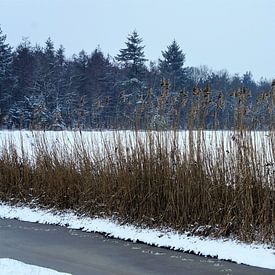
[0,219,274,275]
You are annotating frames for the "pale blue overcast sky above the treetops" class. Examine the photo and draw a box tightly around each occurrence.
[0,0,275,80]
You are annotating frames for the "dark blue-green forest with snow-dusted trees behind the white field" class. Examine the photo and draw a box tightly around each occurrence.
[0,29,270,130]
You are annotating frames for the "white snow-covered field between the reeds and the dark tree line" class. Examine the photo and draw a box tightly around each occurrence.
[0,130,275,167]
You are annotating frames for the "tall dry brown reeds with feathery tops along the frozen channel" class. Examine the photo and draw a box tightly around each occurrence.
[0,82,275,244]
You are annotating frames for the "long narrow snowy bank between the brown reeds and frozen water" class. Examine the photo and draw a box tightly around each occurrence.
[0,204,275,274]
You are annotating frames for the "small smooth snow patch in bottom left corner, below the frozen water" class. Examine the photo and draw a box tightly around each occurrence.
[0,258,70,275]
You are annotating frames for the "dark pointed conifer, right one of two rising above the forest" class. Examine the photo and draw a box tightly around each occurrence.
[159,40,185,91]
